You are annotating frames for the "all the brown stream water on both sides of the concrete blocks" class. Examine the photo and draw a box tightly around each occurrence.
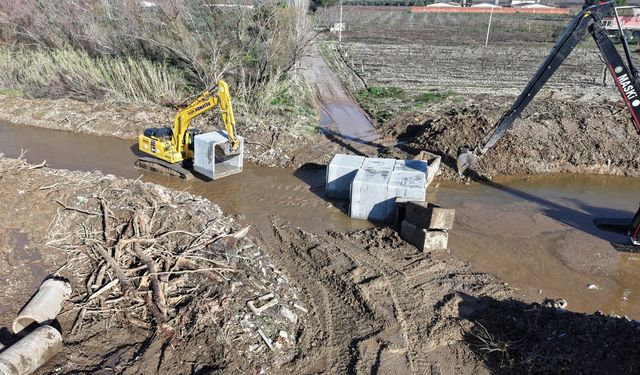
[0,124,640,318]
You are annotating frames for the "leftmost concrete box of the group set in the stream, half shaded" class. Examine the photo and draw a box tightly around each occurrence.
[324,154,365,199]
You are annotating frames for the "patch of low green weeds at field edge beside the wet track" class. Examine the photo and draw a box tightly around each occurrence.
[356,86,456,124]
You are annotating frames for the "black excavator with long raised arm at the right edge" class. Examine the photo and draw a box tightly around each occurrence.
[457,2,640,251]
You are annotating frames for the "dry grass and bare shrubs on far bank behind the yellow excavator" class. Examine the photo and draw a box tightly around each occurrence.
[0,0,313,127]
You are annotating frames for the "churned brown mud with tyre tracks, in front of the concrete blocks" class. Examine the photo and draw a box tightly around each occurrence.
[266,223,507,374]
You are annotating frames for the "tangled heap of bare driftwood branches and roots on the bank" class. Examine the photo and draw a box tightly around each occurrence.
[47,178,251,342]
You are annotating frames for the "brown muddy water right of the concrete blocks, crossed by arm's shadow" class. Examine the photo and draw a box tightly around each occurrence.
[429,175,640,318]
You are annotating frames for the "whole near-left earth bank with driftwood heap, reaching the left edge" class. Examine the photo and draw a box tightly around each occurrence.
[0,158,305,374]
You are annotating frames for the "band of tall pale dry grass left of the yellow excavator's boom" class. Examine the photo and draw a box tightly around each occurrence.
[0,48,187,103]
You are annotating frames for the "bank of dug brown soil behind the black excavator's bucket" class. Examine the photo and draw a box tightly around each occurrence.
[384,95,640,178]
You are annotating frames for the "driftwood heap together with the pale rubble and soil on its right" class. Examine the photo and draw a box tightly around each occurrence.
[25,165,306,372]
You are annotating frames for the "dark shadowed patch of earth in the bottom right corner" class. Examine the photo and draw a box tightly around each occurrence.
[458,295,640,374]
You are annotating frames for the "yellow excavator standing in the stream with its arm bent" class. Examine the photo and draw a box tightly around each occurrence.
[136,80,240,179]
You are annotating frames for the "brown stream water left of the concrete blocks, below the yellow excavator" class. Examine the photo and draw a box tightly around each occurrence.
[0,124,372,235]
